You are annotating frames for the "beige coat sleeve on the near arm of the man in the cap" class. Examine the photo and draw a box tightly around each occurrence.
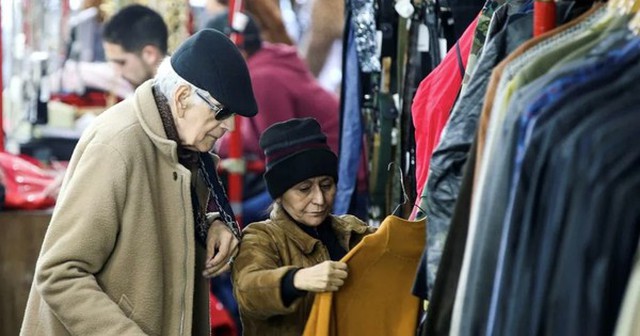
[34,144,144,336]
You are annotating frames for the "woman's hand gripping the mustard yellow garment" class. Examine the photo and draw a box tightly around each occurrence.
[293,260,348,292]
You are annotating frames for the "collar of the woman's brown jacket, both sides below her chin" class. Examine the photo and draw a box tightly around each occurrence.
[271,208,367,254]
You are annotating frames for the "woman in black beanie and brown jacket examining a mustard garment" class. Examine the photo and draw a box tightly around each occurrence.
[232,118,374,336]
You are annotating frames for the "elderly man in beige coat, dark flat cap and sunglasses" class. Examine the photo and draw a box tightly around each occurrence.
[21,30,257,336]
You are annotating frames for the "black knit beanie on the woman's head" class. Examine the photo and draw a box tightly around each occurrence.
[260,118,338,199]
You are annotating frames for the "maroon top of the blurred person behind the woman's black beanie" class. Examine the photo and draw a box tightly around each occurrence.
[217,42,340,159]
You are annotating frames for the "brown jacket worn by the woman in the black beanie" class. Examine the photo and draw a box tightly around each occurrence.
[233,210,375,336]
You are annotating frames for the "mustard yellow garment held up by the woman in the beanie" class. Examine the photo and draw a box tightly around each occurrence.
[304,216,426,336]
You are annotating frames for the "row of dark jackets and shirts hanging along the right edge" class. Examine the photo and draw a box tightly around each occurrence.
[416,0,640,335]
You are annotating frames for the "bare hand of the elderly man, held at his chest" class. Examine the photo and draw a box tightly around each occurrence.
[202,219,239,278]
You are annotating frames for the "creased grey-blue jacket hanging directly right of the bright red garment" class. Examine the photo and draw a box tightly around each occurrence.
[421,0,533,296]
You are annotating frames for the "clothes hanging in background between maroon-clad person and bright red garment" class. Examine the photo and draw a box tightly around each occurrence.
[334,0,480,226]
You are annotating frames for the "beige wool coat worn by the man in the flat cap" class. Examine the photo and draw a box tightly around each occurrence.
[20,81,210,336]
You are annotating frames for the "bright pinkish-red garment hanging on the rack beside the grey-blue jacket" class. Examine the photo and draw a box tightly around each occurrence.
[411,18,478,196]
